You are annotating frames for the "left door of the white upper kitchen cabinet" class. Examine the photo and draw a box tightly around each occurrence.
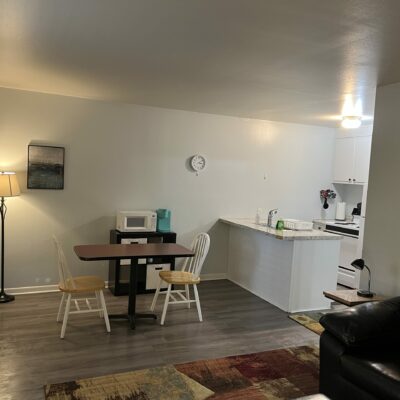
[333,138,355,182]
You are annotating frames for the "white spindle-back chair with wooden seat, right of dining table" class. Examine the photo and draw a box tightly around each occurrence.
[150,233,210,325]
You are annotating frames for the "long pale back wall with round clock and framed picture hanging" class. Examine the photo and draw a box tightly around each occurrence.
[0,89,335,287]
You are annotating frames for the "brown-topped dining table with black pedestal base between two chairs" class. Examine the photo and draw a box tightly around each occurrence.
[74,243,194,329]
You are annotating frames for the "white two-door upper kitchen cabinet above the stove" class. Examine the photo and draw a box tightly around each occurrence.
[333,136,372,184]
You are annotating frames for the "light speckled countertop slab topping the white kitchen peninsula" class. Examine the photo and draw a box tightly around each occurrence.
[219,217,342,240]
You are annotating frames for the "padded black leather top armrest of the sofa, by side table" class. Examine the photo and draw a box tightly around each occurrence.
[320,297,400,346]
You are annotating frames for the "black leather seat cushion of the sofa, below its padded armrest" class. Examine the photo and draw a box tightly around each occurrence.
[341,350,400,400]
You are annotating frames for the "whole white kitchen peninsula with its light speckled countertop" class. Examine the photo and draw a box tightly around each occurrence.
[220,218,341,312]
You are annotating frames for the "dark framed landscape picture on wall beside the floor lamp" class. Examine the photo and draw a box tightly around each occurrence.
[28,144,65,190]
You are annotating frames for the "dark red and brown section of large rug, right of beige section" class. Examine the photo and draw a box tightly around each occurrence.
[175,346,319,400]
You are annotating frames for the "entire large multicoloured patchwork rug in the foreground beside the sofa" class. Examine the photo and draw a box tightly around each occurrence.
[45,346,319,400]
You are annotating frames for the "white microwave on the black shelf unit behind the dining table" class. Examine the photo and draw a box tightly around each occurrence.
[117,211,157,232]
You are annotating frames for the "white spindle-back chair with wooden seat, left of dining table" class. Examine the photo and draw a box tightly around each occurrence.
[53,236,110,339]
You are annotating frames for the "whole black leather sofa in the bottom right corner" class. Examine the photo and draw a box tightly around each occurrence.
[320,297,400,400]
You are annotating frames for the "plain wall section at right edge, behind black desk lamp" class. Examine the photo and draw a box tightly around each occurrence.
[363,83,400,296]
